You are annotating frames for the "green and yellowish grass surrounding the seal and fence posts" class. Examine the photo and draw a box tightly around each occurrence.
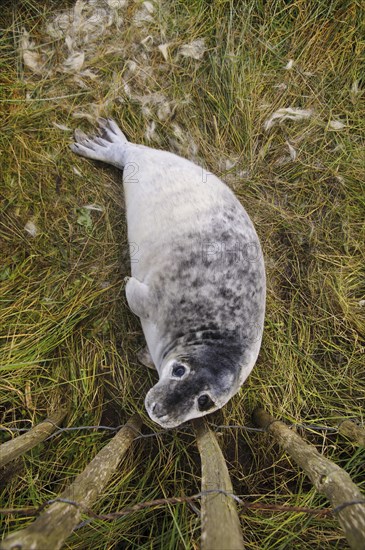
[0,0,365,550]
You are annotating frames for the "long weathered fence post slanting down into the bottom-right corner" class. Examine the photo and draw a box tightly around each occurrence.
[253,408,365,550]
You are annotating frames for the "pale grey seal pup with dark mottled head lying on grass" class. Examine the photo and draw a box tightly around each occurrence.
[71,119,266,428]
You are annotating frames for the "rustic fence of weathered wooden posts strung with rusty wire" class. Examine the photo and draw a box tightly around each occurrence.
[0,409,365,550]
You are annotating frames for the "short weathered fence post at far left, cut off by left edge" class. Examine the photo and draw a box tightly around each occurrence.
[0,409,67,468]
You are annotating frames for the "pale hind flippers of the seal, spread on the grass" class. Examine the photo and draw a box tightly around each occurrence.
[70,118,129,168]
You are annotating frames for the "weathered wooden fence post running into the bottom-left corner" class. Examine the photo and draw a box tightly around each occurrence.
[0,415,142,550]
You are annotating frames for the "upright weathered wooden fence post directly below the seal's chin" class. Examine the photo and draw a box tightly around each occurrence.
[194,419,244,550]
